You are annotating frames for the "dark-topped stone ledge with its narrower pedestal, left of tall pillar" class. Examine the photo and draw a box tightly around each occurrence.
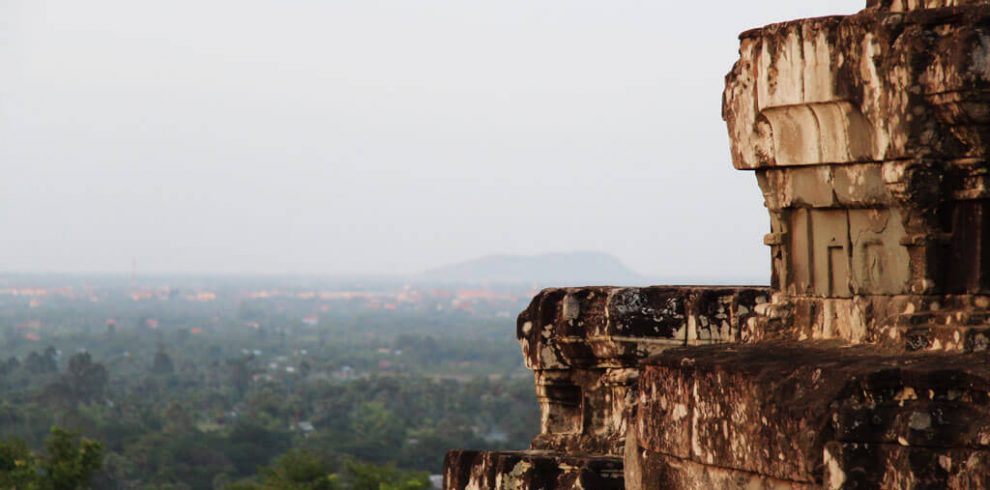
[516,286,770,456]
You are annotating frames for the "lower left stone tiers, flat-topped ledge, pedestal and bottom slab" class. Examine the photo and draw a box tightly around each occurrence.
[444,286,770,490]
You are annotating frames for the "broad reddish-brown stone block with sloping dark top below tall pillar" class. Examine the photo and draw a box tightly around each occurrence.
[626,342,990,488]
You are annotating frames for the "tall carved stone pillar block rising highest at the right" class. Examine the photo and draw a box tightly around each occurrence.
[723,1,990,342]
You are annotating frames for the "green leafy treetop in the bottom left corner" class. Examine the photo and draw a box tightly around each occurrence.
[0,427,103,490]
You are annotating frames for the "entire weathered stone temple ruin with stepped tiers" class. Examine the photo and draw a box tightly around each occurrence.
[444,0,990,490]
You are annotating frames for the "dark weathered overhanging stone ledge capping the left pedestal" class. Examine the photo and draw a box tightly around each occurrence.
[516,286,770,369]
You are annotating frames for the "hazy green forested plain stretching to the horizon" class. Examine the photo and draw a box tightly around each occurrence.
[0,277,539,490]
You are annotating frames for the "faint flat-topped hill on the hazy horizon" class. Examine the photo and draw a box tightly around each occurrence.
[417,252,646,286]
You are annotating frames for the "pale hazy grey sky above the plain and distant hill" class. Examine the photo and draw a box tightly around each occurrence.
[0,0,865,278]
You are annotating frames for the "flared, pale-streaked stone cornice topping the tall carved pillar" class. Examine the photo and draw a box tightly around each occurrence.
[724,2,990,170]
